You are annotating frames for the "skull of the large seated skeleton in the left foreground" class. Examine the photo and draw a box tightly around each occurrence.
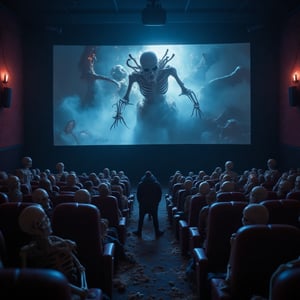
[19,204,52,237]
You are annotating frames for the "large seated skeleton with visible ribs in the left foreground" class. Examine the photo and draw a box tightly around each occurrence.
[19,204,88,299]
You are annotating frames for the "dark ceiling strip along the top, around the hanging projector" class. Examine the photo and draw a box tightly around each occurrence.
[0,0,300,26]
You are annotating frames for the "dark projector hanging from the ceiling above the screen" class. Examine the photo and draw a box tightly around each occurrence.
[142,0,167,26]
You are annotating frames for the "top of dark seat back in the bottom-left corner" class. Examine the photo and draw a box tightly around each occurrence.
[0,268,72,300]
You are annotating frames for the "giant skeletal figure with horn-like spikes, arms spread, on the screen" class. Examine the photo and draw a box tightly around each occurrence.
[111,50,201,142]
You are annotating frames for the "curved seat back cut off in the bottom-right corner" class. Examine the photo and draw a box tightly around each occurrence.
[269,259,300,300]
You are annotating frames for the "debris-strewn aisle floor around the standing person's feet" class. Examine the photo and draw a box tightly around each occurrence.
[112,190,197,300]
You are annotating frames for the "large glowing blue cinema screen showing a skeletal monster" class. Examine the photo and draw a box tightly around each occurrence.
[53,43,251,146]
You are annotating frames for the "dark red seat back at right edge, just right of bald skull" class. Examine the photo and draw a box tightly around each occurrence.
[261,199,300,227]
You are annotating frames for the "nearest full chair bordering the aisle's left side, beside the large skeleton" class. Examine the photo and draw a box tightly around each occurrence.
[52,203,115,297]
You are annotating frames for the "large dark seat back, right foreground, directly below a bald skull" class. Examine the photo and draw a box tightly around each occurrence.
[231,224,300,299]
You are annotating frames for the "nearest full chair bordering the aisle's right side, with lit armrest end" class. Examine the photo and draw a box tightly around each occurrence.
[190,201,248,300]
